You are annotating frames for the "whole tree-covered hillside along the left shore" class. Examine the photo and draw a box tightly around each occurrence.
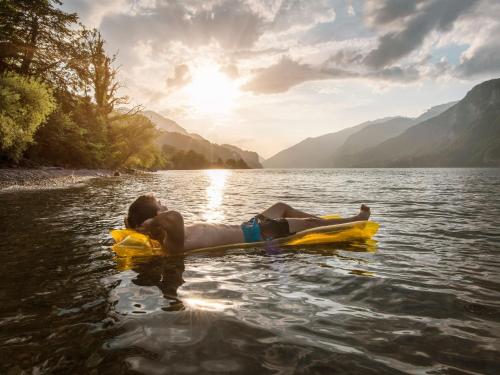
[0,0,256,169]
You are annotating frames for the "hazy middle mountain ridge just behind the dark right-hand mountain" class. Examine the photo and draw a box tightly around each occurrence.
[330,102,457,167]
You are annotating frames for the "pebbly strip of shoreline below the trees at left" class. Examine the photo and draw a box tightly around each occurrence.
[0,167,114,191]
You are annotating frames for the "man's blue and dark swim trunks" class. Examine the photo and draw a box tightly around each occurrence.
[241,214,291,242]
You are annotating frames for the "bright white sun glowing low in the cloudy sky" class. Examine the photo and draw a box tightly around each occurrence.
[185,64,240,114]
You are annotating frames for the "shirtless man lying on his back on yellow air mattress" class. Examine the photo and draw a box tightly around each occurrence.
[125,194,370,254]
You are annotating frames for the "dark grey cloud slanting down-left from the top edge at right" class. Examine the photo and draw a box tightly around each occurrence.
[365,0,478,68]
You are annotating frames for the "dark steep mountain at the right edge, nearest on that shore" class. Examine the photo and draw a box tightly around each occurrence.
[350,79,500,167]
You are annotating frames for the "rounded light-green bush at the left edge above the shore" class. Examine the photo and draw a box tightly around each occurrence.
[0,73,55,161]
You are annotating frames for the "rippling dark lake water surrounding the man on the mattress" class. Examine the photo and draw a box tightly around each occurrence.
[0,169,500,375]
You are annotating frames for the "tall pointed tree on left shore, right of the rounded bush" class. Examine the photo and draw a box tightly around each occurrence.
[29,29,141,168]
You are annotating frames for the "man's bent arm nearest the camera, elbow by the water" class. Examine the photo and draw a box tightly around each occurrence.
[138,211,184,253]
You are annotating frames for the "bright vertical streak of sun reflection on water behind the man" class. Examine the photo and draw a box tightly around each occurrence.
[203,169,229,223]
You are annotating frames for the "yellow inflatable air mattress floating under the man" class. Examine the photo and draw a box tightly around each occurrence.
[111,215,379,257]
